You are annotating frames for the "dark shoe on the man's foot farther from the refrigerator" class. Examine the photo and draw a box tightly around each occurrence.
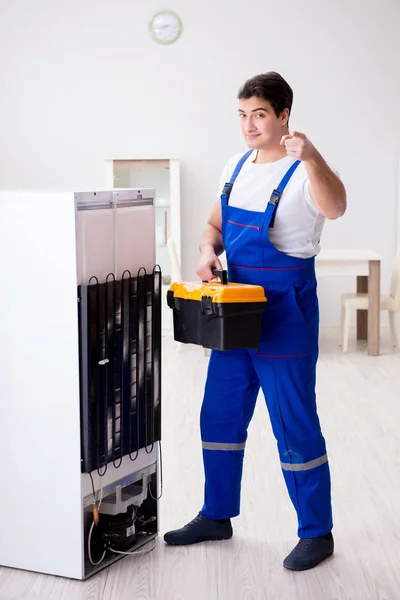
[283,533,334,571]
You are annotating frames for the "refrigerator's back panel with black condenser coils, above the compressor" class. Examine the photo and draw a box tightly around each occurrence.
[75,189,162,473]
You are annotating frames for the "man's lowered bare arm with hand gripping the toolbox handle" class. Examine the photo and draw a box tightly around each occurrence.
[196,198,224,281]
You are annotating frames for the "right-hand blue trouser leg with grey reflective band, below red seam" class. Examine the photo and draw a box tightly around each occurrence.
[254,356,332,537]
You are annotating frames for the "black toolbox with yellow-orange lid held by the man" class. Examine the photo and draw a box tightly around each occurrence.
[167,270,267,350]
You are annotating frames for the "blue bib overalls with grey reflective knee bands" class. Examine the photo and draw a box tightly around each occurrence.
[200,151,332,538]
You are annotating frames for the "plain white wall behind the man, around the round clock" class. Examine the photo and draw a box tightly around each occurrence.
[0,0,400,324]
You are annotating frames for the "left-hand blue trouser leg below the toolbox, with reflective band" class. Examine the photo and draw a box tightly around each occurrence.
[200,350,259,519]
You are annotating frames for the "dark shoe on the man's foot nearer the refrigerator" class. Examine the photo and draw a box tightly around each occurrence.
[164,513,233,546]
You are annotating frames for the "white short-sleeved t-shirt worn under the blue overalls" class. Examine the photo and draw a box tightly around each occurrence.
[218,150,325,258]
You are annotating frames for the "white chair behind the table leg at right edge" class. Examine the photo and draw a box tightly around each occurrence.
[340,252,400,352]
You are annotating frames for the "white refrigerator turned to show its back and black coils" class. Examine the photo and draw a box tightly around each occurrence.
[0,189,161,579]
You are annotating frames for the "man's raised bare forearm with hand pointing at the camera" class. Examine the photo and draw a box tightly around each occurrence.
[281,131,347,219]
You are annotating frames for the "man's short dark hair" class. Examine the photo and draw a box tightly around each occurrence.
[238,71,293,117]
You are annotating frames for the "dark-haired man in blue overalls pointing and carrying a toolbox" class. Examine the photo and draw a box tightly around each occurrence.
[164,72,346,570]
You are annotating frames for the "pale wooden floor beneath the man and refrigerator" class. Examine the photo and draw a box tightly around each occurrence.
[0,330,400,600]
